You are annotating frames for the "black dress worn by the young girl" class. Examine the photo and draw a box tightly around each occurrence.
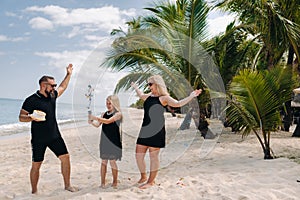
[99,112,122,160]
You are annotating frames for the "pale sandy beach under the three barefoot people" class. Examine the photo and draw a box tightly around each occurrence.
[0,109,300,200]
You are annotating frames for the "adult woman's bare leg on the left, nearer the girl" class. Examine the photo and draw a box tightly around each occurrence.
[135,144,149,183]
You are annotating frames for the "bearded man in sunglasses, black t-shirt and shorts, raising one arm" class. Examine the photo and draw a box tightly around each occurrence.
[19,64,78,194]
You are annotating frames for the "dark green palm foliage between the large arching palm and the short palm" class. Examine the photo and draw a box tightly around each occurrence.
[204,21,260,86]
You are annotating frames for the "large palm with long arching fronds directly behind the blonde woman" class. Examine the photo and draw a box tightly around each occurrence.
[103,0,224,125]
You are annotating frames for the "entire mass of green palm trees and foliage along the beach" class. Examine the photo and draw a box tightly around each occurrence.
[103,0,300,158]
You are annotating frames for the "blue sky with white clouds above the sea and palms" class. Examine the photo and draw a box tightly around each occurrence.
[0,0,233,106]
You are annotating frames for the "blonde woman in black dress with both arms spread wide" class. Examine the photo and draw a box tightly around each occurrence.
[131,75,202,189]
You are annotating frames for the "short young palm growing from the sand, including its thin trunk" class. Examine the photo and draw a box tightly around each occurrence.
[226,67,295,159]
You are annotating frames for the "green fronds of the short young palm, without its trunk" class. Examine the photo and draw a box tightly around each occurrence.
[228,68,291,132]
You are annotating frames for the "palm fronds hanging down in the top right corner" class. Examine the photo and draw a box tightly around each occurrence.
[216,0,300,69]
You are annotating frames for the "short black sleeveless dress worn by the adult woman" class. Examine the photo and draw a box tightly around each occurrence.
[136,96,166,148]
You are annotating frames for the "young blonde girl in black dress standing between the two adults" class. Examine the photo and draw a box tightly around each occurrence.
[89,95,122,188]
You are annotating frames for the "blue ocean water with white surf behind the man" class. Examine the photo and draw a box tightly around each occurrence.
[0,98,105,137]
